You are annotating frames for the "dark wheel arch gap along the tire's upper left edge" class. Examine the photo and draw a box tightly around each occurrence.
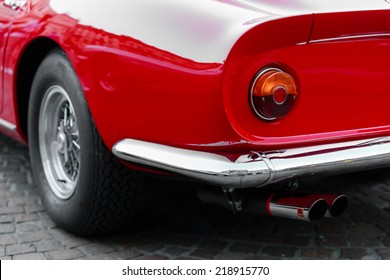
[15,37,61,140]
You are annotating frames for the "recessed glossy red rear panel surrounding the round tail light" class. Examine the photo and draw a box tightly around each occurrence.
[224,11,390,148]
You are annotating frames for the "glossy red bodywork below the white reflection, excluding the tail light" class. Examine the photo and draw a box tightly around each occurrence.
[0,0,390,160]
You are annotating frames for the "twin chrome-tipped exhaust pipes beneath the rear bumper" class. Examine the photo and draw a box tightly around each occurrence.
[198,189,348,222]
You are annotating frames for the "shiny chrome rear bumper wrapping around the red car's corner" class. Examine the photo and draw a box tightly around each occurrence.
[112,137,390,188]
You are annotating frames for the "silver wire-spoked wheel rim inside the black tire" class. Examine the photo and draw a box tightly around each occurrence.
[38,85,80,199]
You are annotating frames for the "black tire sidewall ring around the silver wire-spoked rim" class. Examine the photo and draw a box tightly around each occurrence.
[28,50,95,230]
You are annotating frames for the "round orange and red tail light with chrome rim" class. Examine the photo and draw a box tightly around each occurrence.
[250,68,298,121]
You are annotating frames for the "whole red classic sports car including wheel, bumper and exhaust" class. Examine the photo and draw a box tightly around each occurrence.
[0,0,390,234]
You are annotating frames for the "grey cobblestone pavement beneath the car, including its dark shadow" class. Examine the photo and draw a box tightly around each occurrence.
[0,133,390,260]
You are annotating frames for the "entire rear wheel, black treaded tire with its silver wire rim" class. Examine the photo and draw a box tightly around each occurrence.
[28,49,144,235]
